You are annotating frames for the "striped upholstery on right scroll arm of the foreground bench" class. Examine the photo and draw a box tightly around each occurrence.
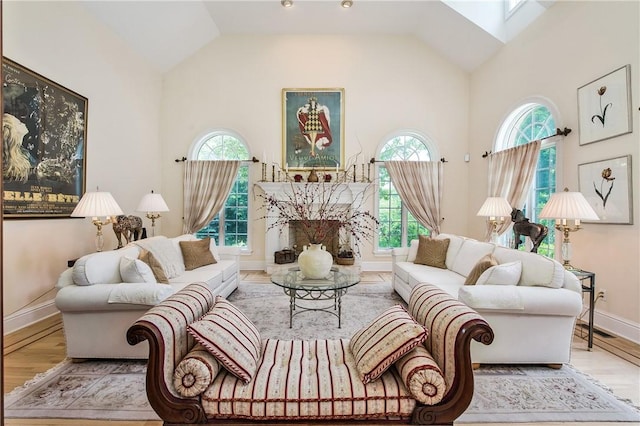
[408,284,484,397]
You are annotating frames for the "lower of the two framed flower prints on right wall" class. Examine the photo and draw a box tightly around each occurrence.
[578,155,633,225]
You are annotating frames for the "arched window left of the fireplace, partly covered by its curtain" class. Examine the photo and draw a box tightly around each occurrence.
[189,130,250,247]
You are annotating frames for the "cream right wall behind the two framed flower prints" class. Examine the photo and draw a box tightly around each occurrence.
[468,2,640,341]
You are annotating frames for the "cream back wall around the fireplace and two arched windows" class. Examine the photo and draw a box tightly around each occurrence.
[160,35,468,264]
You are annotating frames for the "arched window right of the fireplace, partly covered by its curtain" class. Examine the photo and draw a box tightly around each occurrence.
[377,133,433,250]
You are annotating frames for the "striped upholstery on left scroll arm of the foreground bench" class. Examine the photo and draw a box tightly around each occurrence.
[138,283,214,396]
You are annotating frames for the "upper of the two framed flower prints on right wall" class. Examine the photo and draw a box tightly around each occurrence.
[578,65,632,145]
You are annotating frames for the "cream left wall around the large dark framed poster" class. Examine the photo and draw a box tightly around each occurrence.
[2,1,161,332]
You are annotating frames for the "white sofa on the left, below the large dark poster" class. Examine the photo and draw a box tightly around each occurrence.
[55,234,240,359]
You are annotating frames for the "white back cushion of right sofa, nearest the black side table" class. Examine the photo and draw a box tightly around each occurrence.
[494,247,564,288]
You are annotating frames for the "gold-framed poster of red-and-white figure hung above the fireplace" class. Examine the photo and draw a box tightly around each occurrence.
[281,89,344,171]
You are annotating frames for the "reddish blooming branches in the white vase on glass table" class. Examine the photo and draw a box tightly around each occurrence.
[258,169,380,254]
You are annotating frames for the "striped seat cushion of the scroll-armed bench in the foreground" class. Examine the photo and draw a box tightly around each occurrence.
[202,339,416,420]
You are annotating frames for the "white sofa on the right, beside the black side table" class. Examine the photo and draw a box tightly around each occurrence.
[392,234,582,365]
